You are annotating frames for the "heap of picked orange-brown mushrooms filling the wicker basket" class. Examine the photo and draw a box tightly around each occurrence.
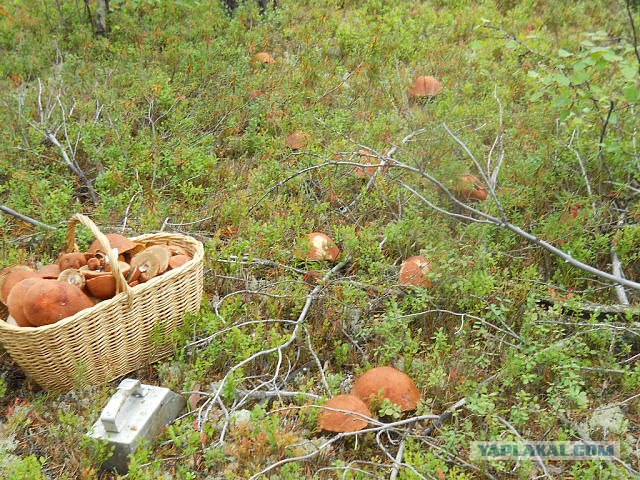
[0,234,191,327]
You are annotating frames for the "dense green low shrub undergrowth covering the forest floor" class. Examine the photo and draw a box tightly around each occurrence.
[0,0,640,479]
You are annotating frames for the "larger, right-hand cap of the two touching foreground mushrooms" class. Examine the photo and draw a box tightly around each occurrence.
[351,367,420,412]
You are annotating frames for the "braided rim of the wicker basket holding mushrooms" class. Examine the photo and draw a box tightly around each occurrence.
[0,232,204,335]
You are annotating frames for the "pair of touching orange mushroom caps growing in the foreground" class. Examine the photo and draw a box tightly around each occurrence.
[318,366,421,432]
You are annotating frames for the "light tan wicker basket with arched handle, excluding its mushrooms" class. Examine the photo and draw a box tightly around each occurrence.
[0,214,204,391]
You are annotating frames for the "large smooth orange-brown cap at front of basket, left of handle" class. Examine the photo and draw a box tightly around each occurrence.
[22,279,94,327]
